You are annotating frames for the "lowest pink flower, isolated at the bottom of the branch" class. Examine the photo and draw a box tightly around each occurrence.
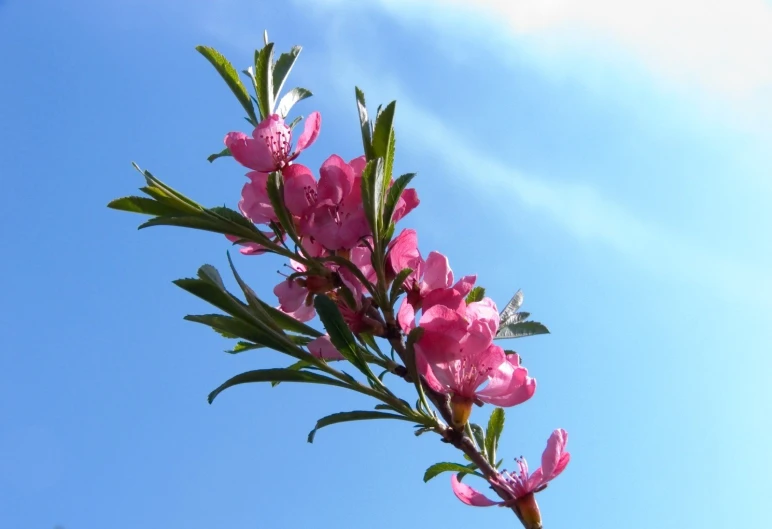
[450,429,571,529]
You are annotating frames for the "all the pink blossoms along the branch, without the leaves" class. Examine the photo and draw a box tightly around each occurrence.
[225,112,569,516]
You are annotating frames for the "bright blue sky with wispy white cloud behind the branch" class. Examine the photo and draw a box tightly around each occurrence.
[0,0,772,529]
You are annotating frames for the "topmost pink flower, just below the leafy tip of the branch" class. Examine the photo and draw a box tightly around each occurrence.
[224,112,322,173]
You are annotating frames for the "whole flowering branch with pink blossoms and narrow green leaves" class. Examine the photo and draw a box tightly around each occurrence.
[109,35,570,529]
